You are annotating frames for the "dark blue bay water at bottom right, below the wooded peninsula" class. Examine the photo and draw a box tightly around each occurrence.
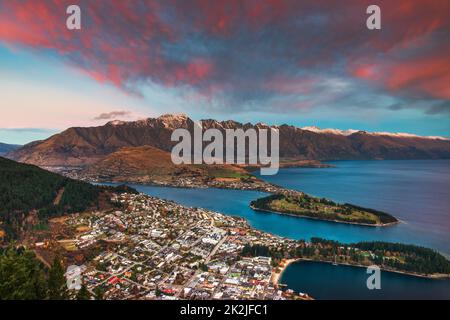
[280,261,450,300]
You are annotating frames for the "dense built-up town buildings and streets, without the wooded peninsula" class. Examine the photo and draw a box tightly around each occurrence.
[49,193,309,300]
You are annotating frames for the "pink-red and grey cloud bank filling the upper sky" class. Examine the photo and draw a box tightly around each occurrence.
[0,0,450,114]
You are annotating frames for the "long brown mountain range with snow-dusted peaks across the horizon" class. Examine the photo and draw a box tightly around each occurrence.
[8,115,450,166]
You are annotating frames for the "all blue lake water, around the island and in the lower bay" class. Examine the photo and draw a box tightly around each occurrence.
[115,160,450,299]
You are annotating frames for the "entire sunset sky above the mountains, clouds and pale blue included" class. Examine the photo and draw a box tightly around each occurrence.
[0,0,450,144]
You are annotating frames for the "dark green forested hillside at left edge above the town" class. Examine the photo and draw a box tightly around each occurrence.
[0,157,102,238]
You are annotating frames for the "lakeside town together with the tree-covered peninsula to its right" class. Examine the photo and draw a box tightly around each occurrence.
[24,189,449,300]
